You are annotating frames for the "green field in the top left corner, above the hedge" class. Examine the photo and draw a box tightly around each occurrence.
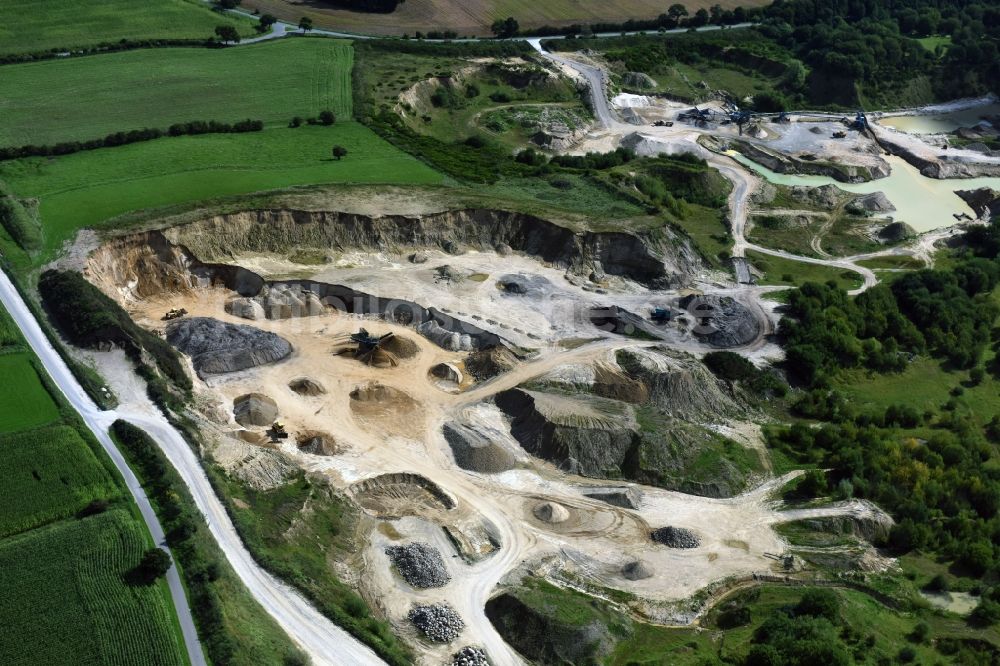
[0,0,255,55]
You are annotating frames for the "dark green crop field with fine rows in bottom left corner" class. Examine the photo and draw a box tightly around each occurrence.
[0,508,187,666]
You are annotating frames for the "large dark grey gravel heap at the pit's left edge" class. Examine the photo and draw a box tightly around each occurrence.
[167,317,292,379]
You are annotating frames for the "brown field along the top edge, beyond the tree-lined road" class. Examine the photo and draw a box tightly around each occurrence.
[243,0,766,36]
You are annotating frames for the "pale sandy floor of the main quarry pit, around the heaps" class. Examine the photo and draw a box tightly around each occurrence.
[117,253,864,664]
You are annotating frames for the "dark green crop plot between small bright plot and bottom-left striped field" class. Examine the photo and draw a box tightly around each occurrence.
[0,422,120,537]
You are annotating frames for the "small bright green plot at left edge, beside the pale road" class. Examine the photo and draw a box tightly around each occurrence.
[0,352,59,430]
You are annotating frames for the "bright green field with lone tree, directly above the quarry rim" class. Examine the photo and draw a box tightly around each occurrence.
[0,122,443,256]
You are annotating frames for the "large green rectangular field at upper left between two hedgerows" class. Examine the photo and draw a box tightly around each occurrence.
[0,39,354,146]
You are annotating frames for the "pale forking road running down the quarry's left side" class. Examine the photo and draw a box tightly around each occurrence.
[0,271,383,666]
